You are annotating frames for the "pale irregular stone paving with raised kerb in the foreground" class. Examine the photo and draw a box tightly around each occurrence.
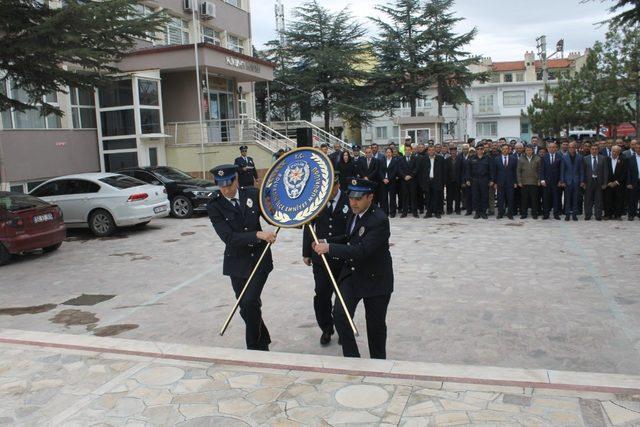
[0,330,640,427]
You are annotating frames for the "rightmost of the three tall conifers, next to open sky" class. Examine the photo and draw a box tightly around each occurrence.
[424,0,488,141]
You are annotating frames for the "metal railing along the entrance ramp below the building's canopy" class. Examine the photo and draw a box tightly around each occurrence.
[165,117,296,153]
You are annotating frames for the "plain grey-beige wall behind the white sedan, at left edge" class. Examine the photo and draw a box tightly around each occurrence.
[0,129,100,182]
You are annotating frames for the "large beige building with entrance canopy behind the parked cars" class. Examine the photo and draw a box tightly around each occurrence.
[0,0,273,191]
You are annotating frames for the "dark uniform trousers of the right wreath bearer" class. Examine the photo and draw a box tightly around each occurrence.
[333,279,391,359]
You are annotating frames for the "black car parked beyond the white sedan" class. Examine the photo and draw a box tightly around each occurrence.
[118,166,218,218]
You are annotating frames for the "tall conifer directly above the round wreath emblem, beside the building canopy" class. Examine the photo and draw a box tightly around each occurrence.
[285,0,367,132]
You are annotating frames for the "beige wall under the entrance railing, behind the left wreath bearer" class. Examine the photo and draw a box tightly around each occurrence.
[166,143,272,176]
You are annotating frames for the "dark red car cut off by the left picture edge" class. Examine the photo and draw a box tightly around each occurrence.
[0,191,67,265]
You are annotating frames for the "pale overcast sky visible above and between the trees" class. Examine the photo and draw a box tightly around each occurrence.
[251,0,611,61]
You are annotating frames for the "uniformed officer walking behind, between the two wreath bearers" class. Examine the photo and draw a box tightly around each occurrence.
[302,172,350,346]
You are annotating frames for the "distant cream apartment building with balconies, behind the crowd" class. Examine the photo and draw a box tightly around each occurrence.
[363,52,586,144]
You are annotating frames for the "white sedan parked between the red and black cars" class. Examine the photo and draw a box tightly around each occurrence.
[29,173,169,237]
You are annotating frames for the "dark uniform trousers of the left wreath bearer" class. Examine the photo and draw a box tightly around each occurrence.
[231,273,271,350]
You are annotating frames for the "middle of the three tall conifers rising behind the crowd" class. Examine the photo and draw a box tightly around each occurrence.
[370,0,430,117]
